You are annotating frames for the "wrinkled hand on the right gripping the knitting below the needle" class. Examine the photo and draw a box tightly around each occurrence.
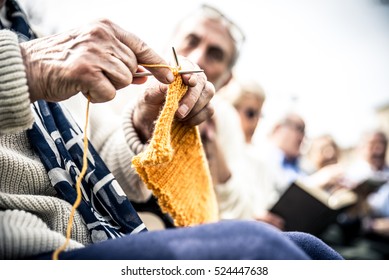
[133,58,215,142]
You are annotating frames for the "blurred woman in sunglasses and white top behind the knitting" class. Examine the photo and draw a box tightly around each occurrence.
[219,77,284,229]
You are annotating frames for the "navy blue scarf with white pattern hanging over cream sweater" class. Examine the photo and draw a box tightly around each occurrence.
[28,100,147,242]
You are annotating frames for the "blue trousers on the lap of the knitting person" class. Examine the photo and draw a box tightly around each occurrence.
[34,221,343,260]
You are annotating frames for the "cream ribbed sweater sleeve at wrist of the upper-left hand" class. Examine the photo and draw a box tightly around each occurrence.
[0,30,34,135]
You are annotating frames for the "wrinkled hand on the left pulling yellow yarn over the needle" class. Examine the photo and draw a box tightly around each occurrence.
[20,20,174,102]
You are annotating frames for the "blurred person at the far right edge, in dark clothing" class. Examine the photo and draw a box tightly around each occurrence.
[322,129,389,259]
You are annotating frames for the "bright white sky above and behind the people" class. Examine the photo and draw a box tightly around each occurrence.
[20,0,389,147]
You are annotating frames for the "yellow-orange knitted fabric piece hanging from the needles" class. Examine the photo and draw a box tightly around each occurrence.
[132,74,218,226]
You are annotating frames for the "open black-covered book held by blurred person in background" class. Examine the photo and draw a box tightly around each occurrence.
[270,182,358,235]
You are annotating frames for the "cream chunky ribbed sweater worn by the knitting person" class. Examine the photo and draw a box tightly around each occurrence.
[0,30,146,259]
